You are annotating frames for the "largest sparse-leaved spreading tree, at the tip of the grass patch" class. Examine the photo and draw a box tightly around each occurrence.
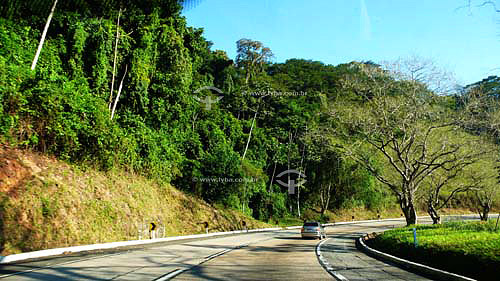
[331,60,488,225]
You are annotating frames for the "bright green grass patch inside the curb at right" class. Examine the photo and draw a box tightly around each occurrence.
[367,221,500,280]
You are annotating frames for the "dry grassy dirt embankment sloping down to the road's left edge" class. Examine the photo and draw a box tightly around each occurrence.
[0,145,269,255]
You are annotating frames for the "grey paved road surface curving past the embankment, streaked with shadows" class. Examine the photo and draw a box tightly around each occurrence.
[0,221,448,281]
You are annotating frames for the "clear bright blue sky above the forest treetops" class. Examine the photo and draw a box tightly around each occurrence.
[183,0,500,85]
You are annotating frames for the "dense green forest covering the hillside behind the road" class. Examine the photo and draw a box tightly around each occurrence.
[0,0,500,223]
